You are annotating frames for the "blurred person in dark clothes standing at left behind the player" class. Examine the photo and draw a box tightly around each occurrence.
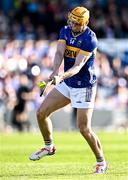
[12,75,30,131]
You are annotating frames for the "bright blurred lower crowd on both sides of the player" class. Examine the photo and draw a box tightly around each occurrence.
[0,40,128,131]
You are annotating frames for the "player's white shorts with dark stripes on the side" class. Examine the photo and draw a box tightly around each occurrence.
[55,82,96,109]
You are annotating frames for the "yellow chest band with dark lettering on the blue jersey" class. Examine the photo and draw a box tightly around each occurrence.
[64,46,80,58]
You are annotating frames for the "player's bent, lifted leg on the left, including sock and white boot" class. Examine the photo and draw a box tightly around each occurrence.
[30,88,70,160]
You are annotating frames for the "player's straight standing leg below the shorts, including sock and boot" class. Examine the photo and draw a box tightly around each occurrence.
[77,109,106,173]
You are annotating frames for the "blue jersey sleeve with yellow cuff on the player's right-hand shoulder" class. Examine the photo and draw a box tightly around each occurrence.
[80,35,97,56]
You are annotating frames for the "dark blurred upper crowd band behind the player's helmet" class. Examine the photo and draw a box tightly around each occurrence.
[0,0,128,40]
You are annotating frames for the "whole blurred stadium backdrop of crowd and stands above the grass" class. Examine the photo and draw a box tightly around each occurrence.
[0,0,128,132]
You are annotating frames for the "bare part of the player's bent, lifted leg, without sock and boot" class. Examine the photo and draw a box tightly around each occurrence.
[37,88,70,144]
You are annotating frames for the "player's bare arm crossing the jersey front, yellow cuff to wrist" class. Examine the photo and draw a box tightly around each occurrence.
[59,51,91,81]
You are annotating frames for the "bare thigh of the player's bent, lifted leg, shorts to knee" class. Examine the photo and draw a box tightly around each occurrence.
[38,88,70,115]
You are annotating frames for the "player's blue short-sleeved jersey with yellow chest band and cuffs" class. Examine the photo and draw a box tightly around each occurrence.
[58,26,97,88]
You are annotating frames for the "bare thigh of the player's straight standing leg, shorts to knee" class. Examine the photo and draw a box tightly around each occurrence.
[77,108,93,128]
